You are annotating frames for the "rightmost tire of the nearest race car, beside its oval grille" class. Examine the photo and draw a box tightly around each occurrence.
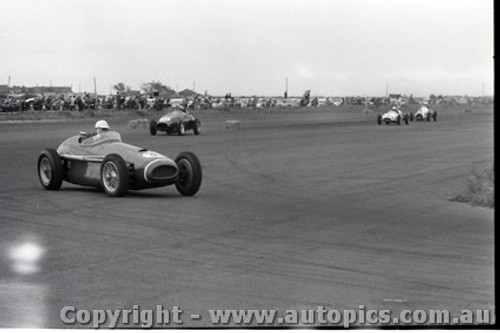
[175,151,203,197]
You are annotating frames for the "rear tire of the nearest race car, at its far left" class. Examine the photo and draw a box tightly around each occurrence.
[37,148,64,191]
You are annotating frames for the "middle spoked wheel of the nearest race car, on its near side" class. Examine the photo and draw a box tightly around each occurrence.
[101,154,129,197]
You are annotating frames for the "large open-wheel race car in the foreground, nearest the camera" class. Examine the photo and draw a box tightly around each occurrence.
[38,132,202,197]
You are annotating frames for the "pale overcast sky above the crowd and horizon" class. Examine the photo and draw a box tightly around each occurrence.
[0,0,494,96]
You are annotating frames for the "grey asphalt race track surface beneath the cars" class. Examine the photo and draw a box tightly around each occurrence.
[0,109,494,328]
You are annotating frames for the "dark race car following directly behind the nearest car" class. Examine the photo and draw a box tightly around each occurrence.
[149,110,201,135]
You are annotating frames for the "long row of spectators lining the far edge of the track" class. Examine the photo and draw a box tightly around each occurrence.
[0,91,493,112]
